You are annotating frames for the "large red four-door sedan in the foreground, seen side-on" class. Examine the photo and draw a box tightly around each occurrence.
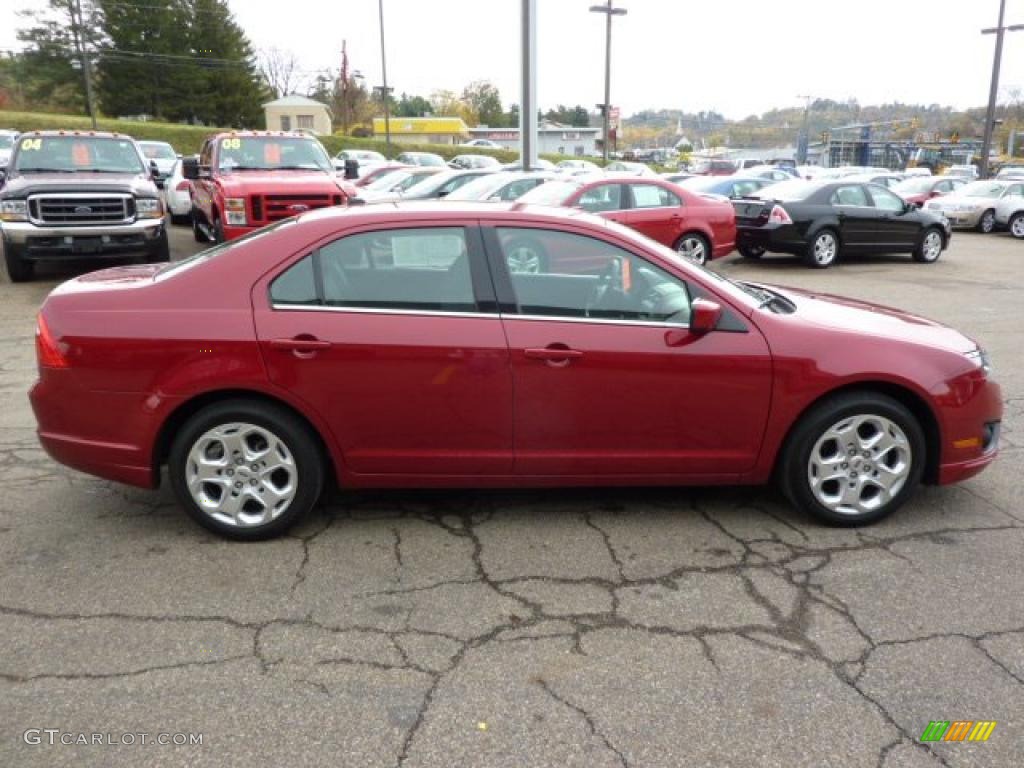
[31,204,1001,539]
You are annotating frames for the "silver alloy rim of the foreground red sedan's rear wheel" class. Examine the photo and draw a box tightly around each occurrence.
[185,423,299,527]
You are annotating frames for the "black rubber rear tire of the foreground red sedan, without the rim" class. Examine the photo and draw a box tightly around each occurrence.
[167,399,325,541]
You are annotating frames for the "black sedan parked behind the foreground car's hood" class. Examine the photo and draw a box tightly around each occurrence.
[732,179,951,269]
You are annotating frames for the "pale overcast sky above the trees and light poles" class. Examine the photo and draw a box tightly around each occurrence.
[0,0,1024,119]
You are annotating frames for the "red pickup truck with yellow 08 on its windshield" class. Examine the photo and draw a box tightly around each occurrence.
[181,131,357,243]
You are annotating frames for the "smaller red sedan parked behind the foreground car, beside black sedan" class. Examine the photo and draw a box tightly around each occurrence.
[518,176,736,264]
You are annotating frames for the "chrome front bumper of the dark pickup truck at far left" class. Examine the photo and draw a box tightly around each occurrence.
[0,218,164,261]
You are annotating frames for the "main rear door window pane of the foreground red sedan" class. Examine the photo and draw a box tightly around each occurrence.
[319,227,477,312]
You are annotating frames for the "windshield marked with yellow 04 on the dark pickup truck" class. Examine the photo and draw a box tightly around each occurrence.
[13,135,146,174]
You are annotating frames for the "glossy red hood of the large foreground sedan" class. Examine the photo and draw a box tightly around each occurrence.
[770,286,978,354]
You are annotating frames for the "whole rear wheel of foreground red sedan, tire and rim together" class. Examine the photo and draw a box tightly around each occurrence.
[168,400,324,541]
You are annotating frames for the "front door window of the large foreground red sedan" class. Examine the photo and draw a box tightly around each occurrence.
[498,227,690,325]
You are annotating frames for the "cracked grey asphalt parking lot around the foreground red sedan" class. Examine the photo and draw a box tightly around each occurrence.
[0,227,1024,768]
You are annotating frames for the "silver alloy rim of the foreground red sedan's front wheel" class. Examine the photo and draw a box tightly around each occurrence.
[807,414,913,517]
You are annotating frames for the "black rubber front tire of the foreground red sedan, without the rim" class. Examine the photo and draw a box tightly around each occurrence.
[778,391,928,527]
